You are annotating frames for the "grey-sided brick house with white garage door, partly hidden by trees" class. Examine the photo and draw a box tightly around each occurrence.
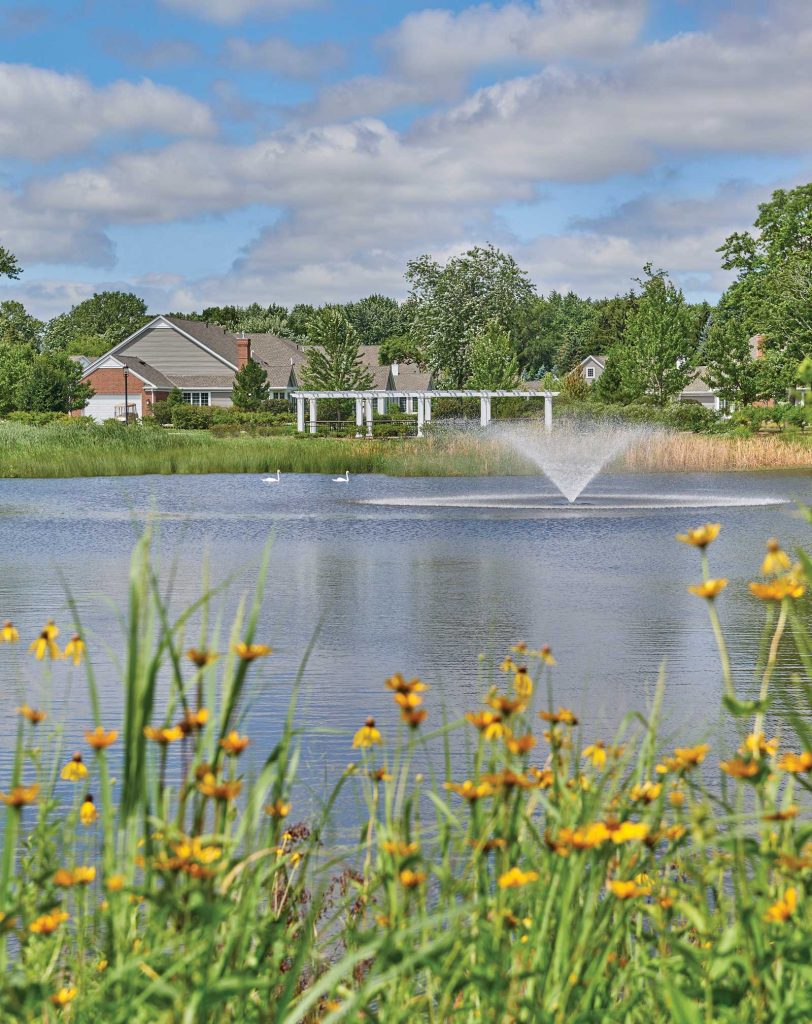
[77,315,428,420]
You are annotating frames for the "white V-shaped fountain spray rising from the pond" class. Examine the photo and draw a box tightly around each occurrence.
[496,419,653,504]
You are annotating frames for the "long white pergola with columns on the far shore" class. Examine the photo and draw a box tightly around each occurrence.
[291,391,559,437]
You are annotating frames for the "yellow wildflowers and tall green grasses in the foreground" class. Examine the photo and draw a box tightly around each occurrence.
[0,524,812,1024]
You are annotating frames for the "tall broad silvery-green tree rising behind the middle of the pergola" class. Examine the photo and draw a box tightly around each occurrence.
[405,246,536,387]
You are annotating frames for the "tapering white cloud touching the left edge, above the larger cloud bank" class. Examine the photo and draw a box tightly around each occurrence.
[0,63,214,160]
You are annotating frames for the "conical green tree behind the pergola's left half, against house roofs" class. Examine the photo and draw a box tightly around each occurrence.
[301,307,373,391]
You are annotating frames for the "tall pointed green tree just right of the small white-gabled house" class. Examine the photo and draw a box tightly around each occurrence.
[617,263,696,406]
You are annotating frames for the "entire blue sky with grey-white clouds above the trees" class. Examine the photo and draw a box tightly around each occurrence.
[0,0,812,316]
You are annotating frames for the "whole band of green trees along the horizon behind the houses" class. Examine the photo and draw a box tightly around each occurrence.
[0,184,812,415]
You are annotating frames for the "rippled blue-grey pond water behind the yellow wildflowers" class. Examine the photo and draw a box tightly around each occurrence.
[0,473,810,811]
